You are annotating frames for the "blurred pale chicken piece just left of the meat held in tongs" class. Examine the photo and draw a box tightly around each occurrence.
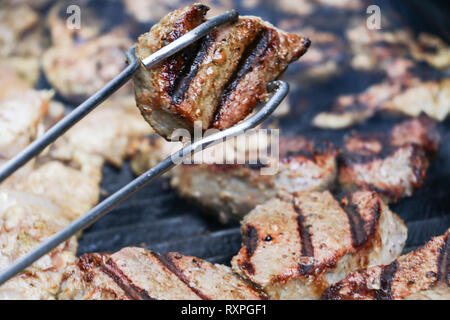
[42,29,132,103]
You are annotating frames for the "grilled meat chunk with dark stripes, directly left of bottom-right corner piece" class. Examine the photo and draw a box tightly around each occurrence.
[231,191,407,299]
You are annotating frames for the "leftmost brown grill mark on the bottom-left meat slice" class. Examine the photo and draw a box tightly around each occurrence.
[100,259,156,300]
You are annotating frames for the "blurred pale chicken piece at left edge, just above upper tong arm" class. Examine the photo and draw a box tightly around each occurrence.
[0,90,53,161]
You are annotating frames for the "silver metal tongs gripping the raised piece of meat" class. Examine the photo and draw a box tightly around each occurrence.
[0,10,289,285]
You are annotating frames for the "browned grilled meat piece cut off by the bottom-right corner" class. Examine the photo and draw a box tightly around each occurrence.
[322,230,450,300]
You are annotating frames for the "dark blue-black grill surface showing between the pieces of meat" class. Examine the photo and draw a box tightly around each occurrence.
[0,1,450,284]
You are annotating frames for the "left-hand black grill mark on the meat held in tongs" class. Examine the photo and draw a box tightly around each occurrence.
[169,34,215,105]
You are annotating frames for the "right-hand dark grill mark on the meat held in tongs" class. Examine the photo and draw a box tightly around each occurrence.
[214,29,273,121]
